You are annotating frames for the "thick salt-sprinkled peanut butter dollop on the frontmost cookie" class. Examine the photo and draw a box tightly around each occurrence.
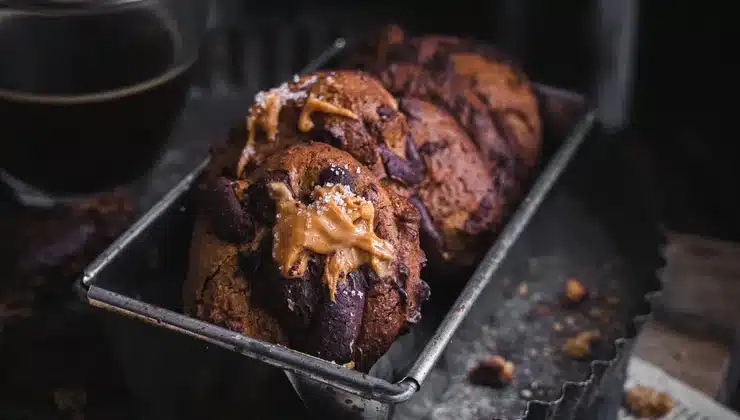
[268,182,393,301]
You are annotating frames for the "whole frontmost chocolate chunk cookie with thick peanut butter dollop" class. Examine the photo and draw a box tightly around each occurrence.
[184,143,429,371]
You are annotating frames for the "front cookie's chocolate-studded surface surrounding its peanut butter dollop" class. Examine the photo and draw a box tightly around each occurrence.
[184,143,429,370]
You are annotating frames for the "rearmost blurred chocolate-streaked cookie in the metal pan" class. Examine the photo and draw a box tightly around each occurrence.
[349,25,542,203]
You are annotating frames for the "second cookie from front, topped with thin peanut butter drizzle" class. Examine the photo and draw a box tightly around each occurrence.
[234,71,416,182]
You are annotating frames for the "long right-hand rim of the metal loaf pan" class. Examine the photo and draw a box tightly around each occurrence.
[405,111,595,384]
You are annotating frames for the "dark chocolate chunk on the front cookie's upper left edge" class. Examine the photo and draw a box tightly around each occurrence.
[205,177,254,243]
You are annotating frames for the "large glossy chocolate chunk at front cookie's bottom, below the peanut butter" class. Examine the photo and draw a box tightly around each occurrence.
[307,270,367,363]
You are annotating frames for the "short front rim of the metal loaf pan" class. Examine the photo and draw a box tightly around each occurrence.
[86,284,419,404]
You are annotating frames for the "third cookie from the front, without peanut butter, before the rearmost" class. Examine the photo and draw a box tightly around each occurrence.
[400,98,504,266]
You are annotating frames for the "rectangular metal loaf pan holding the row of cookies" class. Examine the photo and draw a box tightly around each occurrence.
[78,39,595,419]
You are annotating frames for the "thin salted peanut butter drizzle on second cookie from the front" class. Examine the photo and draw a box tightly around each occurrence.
[236,76,360,178]
